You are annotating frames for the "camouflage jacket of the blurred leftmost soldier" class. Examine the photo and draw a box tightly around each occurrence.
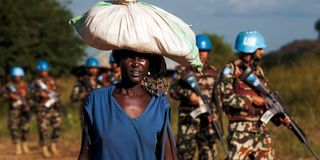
[3,81,30,108]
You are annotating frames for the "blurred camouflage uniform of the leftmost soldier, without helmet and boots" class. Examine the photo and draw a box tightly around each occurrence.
[4,81,31,144]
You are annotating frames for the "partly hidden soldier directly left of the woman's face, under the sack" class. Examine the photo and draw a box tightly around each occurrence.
[99,53,121,86]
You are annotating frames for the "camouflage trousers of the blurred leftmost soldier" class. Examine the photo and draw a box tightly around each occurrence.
[8,108,31,144]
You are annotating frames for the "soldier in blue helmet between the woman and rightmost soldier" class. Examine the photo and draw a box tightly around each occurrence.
[169,35,218,160]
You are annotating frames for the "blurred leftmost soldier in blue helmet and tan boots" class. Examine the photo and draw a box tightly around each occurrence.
[4,67,31,155]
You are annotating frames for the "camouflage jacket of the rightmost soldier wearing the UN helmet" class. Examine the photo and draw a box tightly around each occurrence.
[220,59,268,122]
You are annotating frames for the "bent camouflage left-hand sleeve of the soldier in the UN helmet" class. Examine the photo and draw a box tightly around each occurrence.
[221,64,252,110]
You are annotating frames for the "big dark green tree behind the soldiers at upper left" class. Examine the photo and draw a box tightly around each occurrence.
[0,0,85,76]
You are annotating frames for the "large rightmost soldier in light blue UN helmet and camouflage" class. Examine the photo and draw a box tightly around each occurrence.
[221,31,290,160]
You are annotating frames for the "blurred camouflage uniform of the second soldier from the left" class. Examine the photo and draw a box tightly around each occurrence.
[34,77,62,146]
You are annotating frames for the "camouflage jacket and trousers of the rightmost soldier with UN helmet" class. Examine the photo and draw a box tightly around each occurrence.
[221,59,274,160]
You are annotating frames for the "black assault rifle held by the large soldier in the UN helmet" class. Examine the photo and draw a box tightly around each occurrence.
[240,67,319,160]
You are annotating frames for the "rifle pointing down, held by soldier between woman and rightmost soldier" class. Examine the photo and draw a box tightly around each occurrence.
[182,72,228,156]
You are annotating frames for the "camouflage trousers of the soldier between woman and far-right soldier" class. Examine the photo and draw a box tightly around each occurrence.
[177,113,216,160]
